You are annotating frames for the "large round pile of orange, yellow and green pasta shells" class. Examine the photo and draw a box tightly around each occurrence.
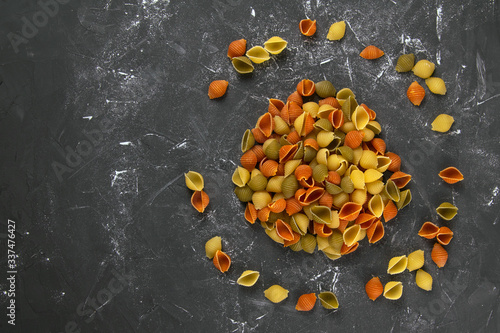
[232,79,412,260]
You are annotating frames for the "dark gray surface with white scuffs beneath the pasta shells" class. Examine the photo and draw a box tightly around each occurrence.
[0,0,500,332]
